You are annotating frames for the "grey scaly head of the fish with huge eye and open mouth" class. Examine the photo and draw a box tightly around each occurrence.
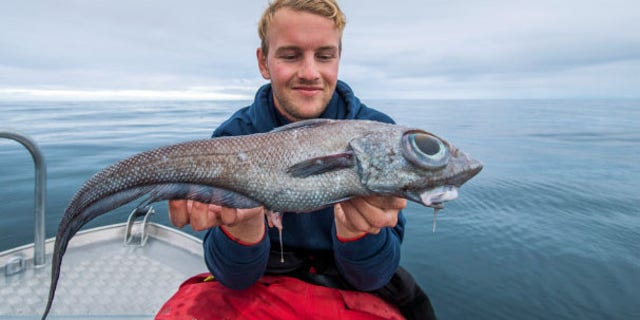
[351,127,482,208]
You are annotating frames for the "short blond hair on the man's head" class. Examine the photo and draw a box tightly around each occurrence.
[258,0,347,55]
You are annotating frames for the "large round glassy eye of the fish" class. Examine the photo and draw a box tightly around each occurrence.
[402,132,449,169]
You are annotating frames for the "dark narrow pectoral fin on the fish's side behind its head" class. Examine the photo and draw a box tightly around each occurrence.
[287,151,355,178]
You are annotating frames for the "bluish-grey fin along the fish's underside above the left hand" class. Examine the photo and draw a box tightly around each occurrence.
[140,183,262,208]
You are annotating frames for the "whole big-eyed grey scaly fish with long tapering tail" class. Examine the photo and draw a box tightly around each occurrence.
[42,119,483,319]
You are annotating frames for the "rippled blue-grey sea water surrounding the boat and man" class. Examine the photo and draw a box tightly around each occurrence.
[0,100,640,320]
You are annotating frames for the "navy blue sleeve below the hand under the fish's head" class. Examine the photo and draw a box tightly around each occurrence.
[332,211,406,291]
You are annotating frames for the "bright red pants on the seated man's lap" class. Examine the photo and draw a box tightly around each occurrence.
[156,274,404,320]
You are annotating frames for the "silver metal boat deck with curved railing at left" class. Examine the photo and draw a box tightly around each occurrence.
[0,129,207,319]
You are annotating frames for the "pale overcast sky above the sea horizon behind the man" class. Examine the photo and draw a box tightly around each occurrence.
[0,0,640,100]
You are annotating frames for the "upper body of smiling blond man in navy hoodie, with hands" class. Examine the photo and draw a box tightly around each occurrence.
[169,0,432,318]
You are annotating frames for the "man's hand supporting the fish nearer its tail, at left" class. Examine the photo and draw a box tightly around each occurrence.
[169,200,265,243]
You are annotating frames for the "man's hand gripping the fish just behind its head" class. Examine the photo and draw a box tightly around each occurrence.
[334,196,407,239]
